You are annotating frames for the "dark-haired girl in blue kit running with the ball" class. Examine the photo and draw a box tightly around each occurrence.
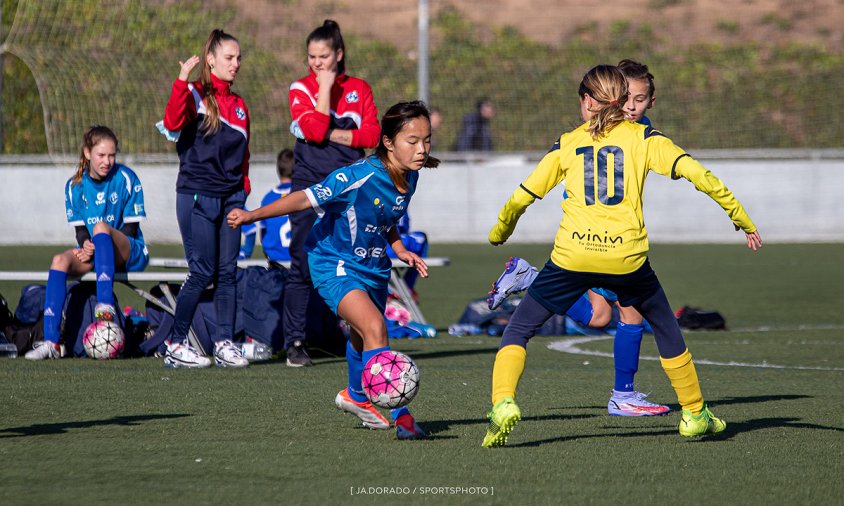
[228,102,439,439]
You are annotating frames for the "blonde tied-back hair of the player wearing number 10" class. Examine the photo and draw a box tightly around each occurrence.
[577,65,628,140]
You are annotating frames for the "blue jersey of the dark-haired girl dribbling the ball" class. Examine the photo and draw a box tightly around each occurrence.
[304,156,419,288]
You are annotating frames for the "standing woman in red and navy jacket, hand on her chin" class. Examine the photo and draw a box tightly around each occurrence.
[282,19,381,367]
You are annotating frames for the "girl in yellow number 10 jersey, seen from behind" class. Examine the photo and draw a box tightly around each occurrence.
[483,65,762,447]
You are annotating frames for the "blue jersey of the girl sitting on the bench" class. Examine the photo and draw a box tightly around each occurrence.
[64,164,146,246]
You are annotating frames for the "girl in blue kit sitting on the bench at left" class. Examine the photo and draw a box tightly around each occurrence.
[25,125,149,360]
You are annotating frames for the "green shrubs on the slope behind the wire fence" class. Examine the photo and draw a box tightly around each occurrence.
[2,0,844,154]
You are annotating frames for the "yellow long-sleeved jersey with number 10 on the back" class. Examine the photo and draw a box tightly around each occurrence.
[489,121,756,274]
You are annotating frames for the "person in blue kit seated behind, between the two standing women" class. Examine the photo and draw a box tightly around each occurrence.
[238,148,293,264]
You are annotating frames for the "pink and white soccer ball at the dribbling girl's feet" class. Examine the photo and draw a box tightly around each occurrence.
[361,350,419,409]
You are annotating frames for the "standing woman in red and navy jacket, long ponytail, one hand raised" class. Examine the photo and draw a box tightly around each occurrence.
[164,29,249,367]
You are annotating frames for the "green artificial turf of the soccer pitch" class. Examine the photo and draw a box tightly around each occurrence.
[0,244,844,504]
